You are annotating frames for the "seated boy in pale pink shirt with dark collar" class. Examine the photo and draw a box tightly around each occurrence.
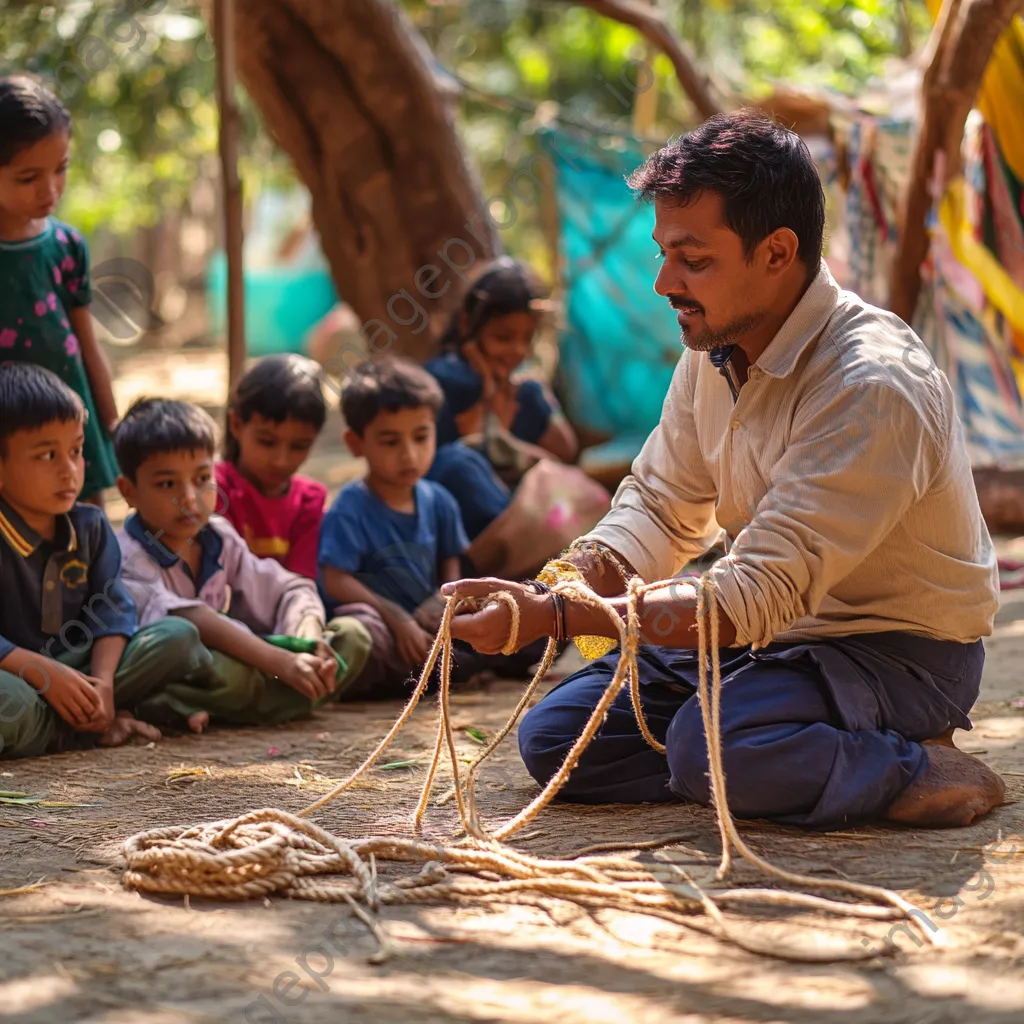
[114,398,370,728]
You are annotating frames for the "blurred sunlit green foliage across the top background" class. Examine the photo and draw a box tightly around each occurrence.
[0,0,929,256]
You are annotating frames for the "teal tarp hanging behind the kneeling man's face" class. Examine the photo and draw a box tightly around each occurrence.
[543,132,682,449]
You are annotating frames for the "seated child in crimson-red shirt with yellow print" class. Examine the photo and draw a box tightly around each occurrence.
[216,355,327,580]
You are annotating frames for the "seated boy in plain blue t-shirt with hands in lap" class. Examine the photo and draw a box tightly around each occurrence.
[317,359,540,699]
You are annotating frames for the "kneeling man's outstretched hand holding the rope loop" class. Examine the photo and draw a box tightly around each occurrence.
[441,579,555,654]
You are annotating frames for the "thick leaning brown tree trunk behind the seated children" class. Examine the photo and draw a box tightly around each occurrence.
[212,0,501,373]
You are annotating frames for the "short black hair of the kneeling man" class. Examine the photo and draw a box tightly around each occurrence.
[627,111,825,276]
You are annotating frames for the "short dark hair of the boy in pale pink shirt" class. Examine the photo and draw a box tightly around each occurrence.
[114,398,217,483]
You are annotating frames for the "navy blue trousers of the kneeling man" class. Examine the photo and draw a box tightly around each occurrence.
[519,633,985,829]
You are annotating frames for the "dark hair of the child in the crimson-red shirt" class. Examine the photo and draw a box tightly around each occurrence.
[224,353,327,463]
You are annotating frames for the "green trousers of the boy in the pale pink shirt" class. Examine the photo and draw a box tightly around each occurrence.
[136,618,373,725]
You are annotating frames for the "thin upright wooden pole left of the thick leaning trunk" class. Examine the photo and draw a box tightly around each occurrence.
[213,0,246,388]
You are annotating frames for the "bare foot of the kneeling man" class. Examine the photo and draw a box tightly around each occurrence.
[884,733,1007,828]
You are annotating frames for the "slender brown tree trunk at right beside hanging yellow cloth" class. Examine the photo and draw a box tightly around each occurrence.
[889,0,1024,323]
